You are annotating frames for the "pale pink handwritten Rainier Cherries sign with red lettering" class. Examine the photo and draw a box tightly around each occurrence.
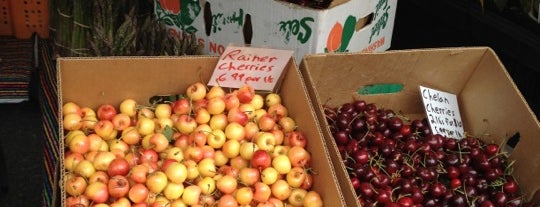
[208,46,293,90]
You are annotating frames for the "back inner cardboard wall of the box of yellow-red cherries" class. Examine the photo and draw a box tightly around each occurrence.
[58,56,217,108]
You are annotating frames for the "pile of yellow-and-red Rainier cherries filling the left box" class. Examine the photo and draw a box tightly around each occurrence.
[61,82,326,207]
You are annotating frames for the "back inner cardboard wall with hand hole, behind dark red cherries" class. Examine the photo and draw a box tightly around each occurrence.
[301,49,484,114]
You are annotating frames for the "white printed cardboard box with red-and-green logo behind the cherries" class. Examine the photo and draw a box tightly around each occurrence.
[155,0,397,63]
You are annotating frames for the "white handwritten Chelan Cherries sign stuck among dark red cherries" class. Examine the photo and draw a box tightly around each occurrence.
[420,86,464,139]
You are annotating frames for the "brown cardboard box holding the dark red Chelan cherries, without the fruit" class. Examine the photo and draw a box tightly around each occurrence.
[300,47,540,206]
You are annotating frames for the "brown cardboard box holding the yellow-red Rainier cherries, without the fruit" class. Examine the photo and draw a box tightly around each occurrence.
[57,56,345,206]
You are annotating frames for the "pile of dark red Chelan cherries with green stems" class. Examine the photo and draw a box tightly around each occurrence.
[324,100,532,207]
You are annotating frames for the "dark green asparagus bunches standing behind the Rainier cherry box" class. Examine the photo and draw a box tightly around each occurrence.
[50,0,201,57]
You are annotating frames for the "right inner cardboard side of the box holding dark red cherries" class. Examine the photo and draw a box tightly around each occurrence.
[459,49,540,200]
